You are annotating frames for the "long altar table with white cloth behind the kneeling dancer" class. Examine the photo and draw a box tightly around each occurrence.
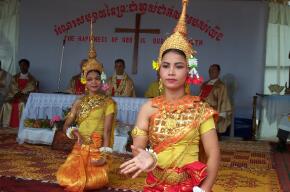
[17,93,147,152]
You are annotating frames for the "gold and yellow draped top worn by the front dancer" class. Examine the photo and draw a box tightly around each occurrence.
[149,95,216,169]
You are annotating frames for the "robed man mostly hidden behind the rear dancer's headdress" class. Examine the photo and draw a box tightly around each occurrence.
[68,59,87,95]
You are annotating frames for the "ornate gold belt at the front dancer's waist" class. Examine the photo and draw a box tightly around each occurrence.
[152,167,190,185]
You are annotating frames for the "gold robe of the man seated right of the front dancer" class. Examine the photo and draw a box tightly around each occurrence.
[201,80,232,133]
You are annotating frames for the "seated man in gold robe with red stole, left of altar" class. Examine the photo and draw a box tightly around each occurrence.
[0,59,37,127]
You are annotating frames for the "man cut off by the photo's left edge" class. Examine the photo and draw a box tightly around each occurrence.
[0,61,11,108]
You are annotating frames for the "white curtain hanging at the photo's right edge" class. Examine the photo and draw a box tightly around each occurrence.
[264,3,290,94]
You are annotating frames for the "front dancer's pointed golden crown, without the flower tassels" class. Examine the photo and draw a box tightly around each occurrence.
[158,0,195,64]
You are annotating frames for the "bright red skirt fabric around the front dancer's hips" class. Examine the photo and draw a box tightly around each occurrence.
[144,161,207,192]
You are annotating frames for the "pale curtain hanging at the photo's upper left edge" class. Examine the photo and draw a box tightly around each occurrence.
[0,0,20,74]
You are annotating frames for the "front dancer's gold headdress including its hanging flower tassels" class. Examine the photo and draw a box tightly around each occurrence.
[152,0,202,84]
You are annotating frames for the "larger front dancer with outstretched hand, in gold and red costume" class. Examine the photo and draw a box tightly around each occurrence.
[121,0,220,192]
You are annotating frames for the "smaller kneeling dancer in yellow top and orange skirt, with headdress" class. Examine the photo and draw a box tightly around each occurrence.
[56,26,116,192]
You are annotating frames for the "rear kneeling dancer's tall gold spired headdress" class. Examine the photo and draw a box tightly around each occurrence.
[81,21,106,84]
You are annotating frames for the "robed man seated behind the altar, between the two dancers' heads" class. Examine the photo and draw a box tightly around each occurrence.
[108,59,136,97]
